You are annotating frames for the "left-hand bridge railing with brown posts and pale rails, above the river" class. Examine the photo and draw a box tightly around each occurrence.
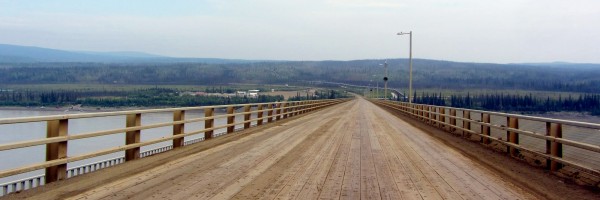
[0,99,347,196]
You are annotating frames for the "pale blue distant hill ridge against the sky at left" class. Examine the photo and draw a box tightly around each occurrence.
[0,44,256,63]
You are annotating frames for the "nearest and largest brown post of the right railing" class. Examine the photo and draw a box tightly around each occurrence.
[546,122,563,171]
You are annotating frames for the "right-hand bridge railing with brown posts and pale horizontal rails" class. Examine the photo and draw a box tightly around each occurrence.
[374,100,600,185]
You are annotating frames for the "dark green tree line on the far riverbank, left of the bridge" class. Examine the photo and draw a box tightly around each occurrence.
[0,87,284,107]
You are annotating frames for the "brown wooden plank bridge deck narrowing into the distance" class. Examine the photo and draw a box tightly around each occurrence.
[9,99,535,199]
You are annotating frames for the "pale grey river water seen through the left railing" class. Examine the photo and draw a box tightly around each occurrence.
[0,109,255,184]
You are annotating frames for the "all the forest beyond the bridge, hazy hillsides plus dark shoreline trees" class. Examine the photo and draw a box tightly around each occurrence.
[0,59,600,111]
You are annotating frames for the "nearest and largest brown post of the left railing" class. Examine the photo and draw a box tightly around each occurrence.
[45,119,69,184]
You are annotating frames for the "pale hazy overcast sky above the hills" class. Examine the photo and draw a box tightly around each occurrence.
[0,0,600,63]
